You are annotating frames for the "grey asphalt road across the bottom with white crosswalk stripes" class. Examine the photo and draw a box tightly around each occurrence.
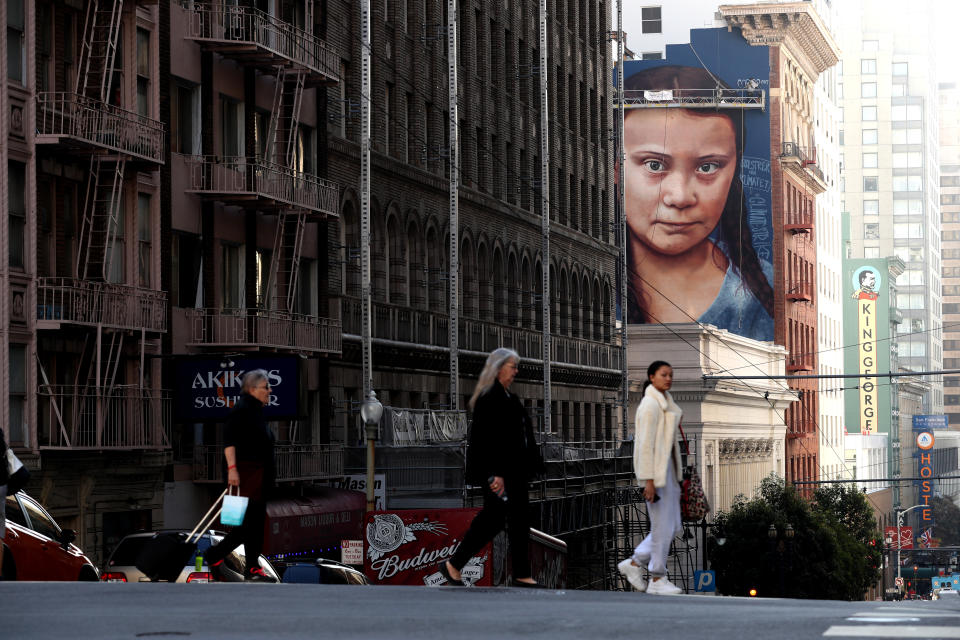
[0,582,960,640]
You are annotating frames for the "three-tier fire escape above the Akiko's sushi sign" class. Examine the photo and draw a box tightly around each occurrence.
[187,2,341,353]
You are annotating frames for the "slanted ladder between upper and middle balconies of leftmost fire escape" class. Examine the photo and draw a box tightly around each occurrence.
[77,156,127,281]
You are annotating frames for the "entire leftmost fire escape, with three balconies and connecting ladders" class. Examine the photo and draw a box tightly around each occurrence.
[36,0,170,450]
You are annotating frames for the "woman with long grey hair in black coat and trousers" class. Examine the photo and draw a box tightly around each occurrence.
[440,348,544,587]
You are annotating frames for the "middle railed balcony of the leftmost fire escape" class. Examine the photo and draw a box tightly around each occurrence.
[37,278,167,333]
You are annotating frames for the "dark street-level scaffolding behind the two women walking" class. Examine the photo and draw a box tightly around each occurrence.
[344,406,709,591]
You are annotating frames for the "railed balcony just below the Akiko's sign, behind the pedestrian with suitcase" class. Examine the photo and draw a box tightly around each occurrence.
[193,444,343,483]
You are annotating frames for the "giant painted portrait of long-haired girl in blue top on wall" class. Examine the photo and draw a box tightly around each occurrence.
[623,65,773,340]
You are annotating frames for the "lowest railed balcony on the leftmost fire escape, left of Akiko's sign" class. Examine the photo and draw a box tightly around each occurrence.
[37,385,171,450]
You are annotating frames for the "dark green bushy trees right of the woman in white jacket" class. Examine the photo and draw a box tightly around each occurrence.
[709,475,881,600]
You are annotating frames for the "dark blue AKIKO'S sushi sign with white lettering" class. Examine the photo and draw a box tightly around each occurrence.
[175,357,300,420]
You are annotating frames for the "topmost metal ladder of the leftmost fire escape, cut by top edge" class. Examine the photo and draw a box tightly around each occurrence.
[74,0,123,102]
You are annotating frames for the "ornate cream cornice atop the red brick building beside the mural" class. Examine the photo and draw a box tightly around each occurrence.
[720,2,840,80]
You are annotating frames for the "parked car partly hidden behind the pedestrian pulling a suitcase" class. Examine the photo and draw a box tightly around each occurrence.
[101,530,280,582]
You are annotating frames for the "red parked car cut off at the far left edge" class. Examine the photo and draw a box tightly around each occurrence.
[2,491,100,582]
